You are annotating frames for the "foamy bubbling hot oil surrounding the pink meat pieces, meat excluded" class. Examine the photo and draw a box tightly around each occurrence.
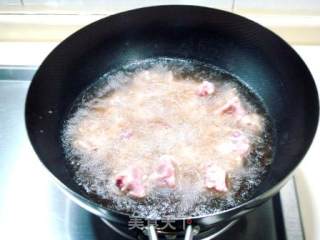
[62,58,272,218]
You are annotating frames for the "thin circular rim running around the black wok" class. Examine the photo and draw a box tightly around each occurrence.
[25,4,319,222]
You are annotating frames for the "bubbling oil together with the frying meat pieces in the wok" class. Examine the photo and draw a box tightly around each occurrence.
[62,58,272,218]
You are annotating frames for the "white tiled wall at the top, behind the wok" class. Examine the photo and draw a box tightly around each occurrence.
[0,0,320,15]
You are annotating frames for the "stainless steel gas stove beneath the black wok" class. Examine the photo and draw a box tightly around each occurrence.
[0,66,304,240]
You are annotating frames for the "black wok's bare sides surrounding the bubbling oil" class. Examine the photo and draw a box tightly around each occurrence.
[25,6,319,238]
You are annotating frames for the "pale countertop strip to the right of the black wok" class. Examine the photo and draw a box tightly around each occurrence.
[294,46,320,240]
